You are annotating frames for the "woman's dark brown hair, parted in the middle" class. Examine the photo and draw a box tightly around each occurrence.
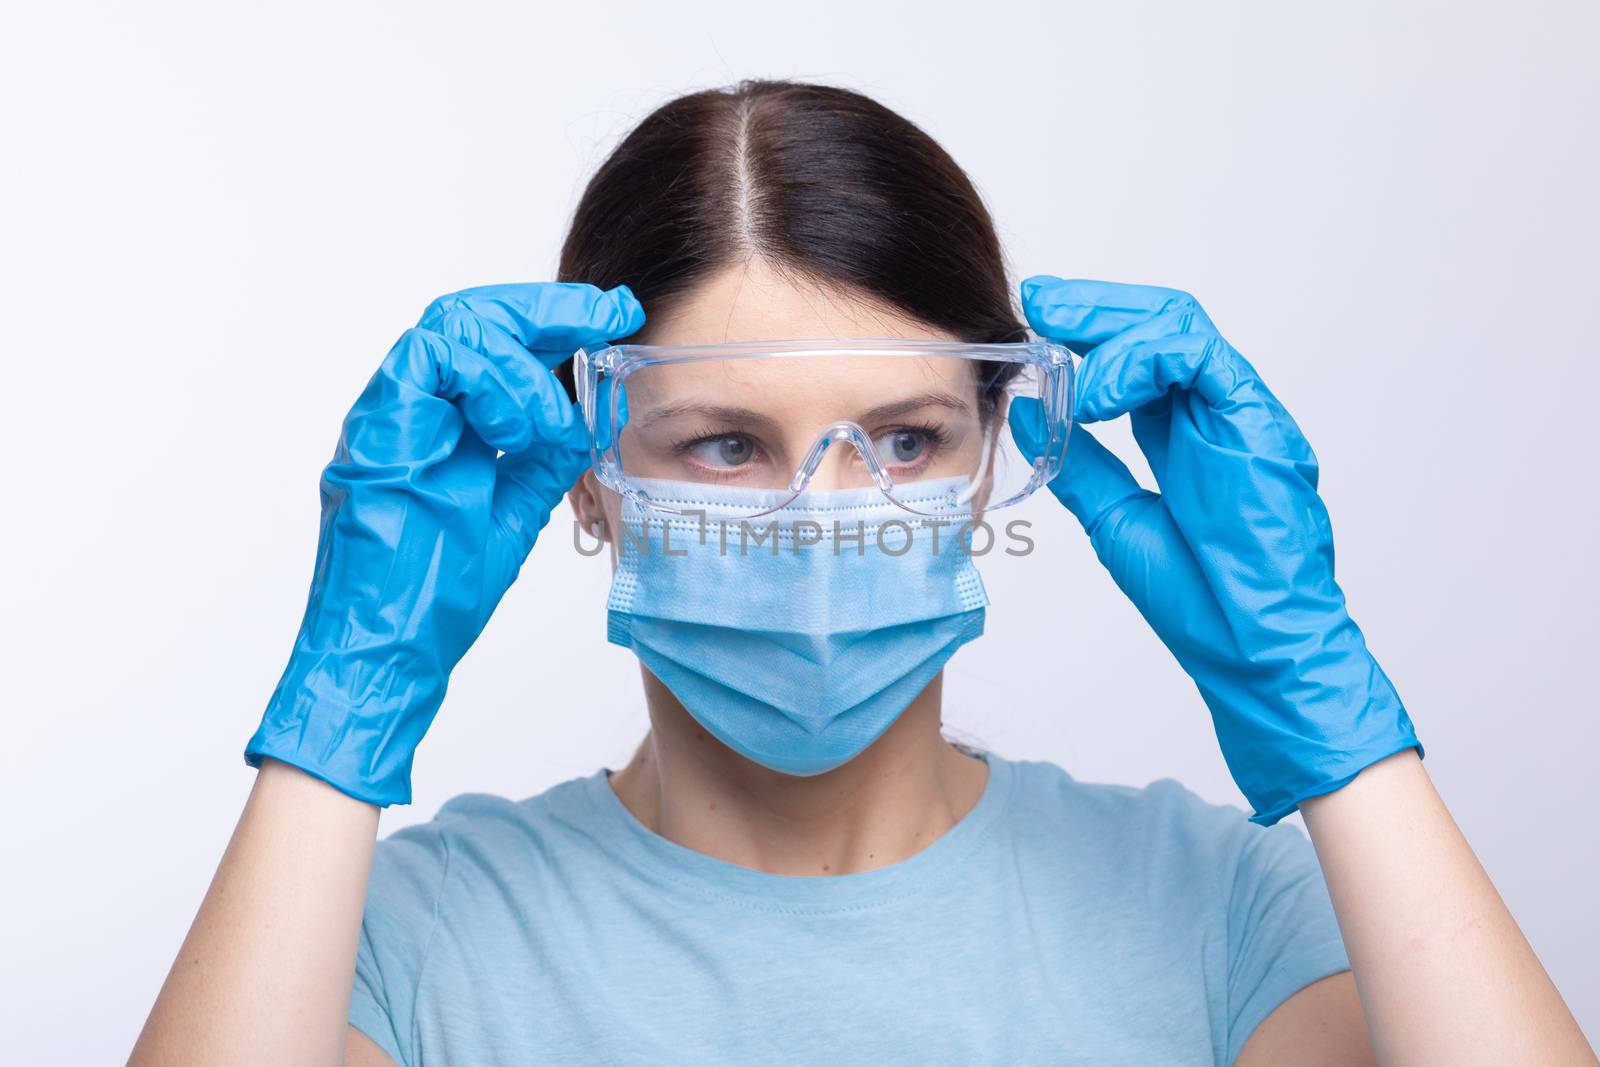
[557,82,1027,398]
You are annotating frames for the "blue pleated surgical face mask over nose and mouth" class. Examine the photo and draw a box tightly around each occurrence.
[606,482,989,774]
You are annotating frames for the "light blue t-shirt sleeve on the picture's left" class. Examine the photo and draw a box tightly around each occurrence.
[350,824,450,1067]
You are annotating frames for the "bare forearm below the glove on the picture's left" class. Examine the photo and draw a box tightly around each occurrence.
[130,760,378,1065]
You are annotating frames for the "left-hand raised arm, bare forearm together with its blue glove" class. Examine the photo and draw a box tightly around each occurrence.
[131,283,645,1065]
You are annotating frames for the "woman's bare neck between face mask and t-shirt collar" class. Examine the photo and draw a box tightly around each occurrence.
[611,672,989,875]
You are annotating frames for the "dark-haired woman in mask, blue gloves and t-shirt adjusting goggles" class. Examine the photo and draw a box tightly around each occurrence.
[133,83,1594,1064]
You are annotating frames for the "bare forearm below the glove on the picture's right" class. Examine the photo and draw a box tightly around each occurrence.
[1301,750,1595,1064]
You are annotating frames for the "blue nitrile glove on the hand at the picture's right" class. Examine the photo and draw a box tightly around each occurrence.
[1011,275,1421,825]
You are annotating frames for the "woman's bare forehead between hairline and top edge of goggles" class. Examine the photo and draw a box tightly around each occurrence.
[632,258,958,344]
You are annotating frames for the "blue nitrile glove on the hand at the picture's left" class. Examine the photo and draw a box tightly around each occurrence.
[245,283,645,805]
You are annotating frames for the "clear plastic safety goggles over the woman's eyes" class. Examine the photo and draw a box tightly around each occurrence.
[574,339,1074,517]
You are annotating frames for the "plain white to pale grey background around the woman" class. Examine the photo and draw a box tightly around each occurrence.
[0,0,1600,1064]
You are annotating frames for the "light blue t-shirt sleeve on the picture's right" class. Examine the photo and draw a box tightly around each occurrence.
[1227,824,1350,1062]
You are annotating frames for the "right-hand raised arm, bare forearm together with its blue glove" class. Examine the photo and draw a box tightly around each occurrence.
[1011,275,1595,1064]
